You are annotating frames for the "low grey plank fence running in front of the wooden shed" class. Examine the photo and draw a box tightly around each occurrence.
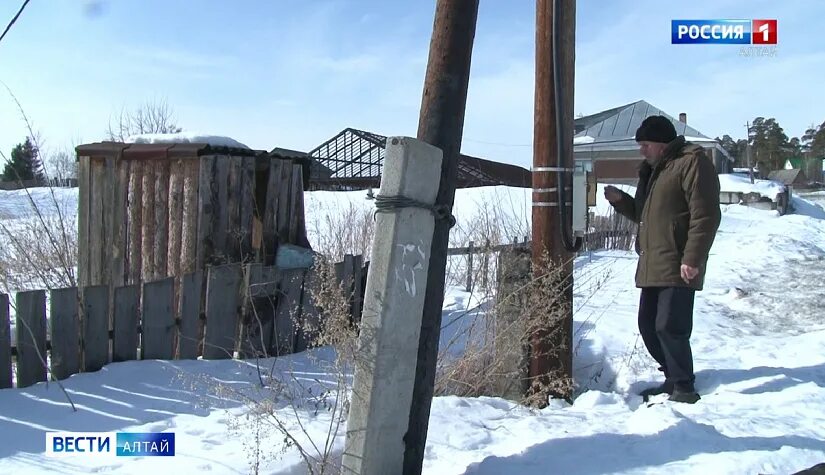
[0,256,365,389]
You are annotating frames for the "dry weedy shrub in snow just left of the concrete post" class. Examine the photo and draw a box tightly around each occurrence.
[210,260,358,474]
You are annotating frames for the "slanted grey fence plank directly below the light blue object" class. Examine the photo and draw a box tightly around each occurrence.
[270,269,306,356]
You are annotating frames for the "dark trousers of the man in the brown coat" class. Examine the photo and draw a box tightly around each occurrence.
[639,287,696,392]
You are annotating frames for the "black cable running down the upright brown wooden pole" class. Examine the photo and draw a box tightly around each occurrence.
[553,0,582,252]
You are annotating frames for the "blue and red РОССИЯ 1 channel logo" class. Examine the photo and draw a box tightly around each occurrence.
[670,20,778,45]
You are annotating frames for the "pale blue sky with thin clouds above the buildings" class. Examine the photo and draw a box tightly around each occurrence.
[0,0,825,166]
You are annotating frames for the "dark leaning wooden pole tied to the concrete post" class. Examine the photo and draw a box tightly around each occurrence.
[402,0,478,474]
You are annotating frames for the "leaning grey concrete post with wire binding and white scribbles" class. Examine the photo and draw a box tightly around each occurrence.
[342,137,442,475]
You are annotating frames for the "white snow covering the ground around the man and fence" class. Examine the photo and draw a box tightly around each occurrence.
[0,183,825,475]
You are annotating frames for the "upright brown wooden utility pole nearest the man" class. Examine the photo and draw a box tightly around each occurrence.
[528,0,576,406]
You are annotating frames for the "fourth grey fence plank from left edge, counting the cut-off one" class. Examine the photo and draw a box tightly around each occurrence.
[81,285,109,373]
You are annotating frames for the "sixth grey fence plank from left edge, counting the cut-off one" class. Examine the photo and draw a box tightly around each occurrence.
[140,277,175,360]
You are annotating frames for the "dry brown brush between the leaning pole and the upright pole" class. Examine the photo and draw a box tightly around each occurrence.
[436,250,572,405]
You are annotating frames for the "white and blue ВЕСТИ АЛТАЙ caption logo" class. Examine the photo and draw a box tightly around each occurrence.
[46,432,175,457]
